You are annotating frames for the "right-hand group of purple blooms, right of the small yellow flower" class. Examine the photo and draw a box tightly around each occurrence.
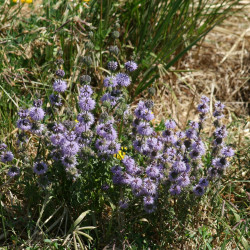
[111,96,234,213]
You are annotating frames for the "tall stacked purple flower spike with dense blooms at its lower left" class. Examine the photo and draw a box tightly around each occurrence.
[47,85,95,172]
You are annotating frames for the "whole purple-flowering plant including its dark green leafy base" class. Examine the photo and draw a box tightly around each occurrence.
[0,52,234,223]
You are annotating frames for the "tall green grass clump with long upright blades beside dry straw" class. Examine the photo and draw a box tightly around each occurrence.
[87,0,239,98]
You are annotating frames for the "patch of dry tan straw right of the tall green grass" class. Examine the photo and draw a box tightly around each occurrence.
[154,3,250,127]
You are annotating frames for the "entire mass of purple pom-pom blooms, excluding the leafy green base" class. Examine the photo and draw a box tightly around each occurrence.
[7,61,234,213]
